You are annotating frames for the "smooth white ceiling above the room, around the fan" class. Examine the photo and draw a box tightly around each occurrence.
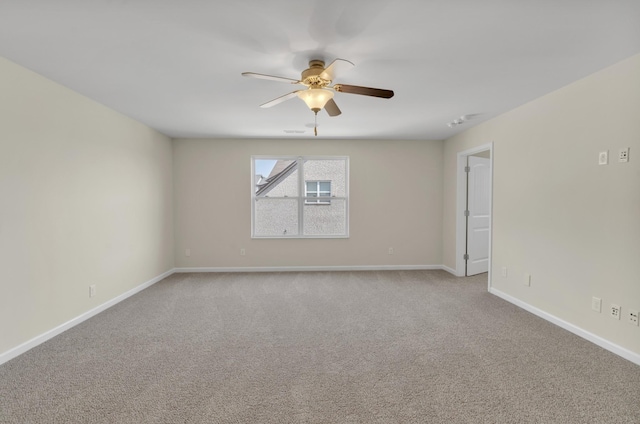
[0,0,640,139]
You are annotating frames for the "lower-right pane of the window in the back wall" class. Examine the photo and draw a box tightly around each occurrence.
[303,199,347,236]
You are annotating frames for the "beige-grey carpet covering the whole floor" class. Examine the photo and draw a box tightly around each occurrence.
[0,271,640,424]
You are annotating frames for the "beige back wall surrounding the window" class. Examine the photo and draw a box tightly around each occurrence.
[174,139,443,267]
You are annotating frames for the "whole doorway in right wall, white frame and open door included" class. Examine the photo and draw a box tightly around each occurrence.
[456,143,493,284]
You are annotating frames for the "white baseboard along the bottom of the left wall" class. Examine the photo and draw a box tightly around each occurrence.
[0,268,175,365]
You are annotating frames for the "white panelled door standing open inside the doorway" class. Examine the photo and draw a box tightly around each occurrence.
[467,156,491,275]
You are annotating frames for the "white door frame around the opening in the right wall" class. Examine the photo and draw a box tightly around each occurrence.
[456,142,493,288]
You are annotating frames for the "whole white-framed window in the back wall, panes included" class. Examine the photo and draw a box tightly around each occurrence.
[251,156,349,238]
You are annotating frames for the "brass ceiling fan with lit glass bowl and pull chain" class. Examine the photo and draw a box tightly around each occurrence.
[242,59,393,135]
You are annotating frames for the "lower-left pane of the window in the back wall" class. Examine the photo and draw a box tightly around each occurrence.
[254,198,298,237]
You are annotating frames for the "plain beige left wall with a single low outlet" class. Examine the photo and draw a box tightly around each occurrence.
[0,58,173,354]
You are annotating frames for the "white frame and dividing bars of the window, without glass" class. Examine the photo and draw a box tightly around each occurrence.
[250,155,349,239]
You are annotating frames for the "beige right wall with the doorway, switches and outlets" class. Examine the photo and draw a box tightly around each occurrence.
[443,55,640,354]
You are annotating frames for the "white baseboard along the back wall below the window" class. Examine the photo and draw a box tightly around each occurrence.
[174,265,448,273]
